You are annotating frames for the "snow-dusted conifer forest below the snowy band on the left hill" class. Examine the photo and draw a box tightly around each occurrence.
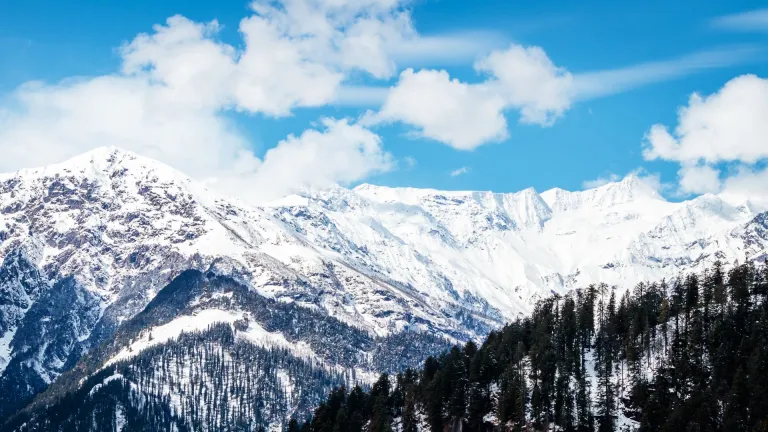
[1,323,356,432]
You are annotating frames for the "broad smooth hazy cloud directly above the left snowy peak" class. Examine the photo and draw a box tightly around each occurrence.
[0,76,259,178]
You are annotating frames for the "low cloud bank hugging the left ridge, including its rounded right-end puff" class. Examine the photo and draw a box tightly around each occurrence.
[0,73,393,202]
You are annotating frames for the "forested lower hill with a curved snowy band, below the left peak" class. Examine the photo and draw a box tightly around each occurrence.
[0,270,450,432]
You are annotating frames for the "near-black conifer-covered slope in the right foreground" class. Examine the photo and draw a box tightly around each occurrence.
[296,262,768,432]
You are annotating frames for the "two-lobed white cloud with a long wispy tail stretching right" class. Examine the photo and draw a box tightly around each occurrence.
[372,44,744,150]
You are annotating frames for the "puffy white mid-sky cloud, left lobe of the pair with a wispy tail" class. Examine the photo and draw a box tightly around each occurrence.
[370,69,507,150]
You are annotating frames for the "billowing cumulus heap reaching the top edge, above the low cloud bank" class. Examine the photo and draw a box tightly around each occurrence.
[121,0,419,116]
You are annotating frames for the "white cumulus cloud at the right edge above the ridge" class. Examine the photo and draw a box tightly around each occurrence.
[643,75,768,199]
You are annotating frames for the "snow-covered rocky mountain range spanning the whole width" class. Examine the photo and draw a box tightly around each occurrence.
[0,148,768,428]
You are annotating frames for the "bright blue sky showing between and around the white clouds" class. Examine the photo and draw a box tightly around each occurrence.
[0,0,768,202]
